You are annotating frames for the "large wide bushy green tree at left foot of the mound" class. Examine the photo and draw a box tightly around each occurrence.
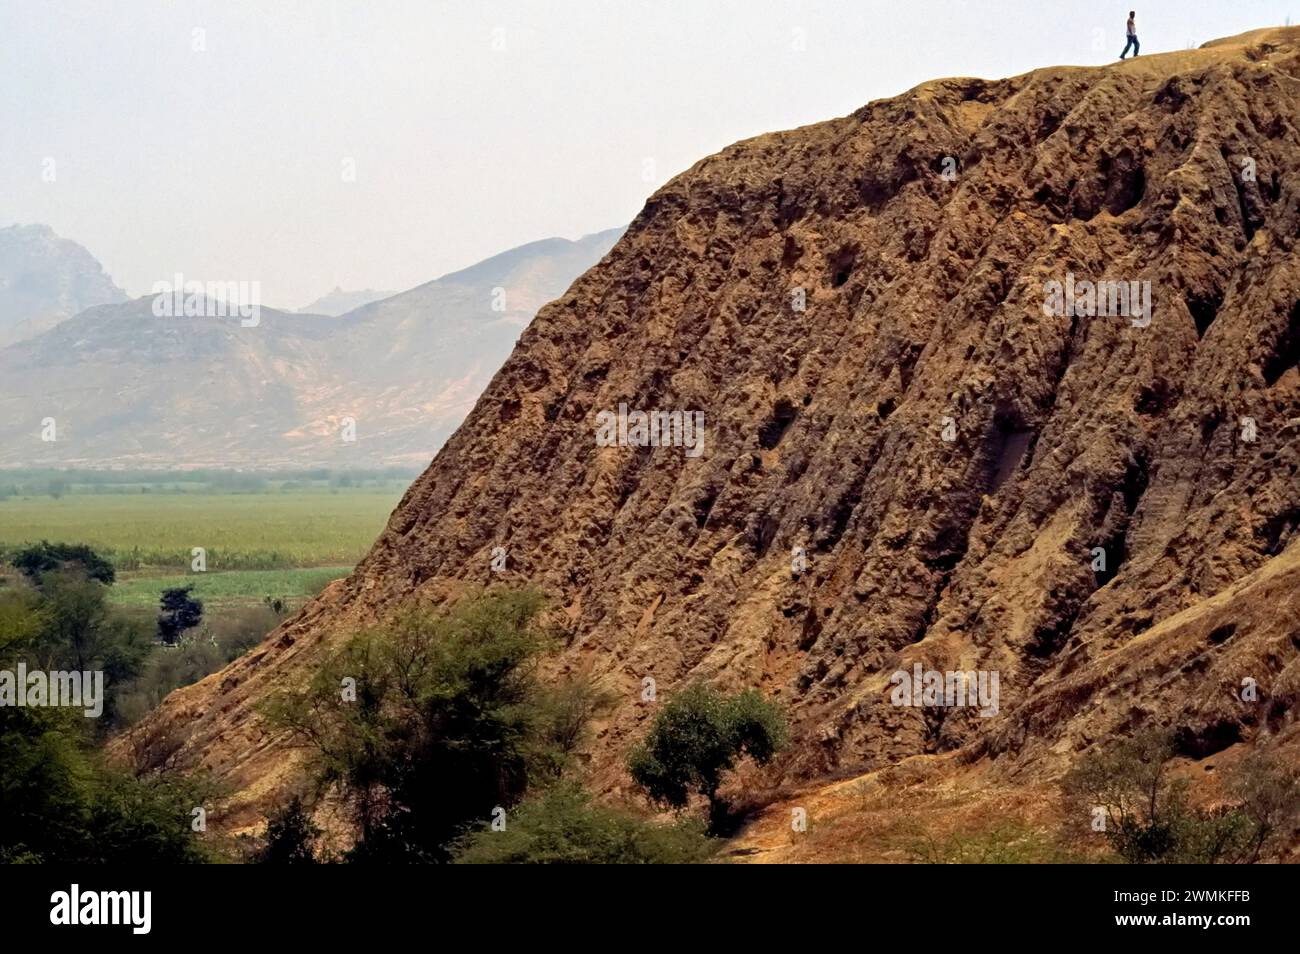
[268,591,577,862]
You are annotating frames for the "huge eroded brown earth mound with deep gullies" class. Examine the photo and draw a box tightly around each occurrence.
[120,29,1300,842]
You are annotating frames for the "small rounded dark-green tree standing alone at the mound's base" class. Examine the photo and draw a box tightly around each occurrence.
[628,682,787,832]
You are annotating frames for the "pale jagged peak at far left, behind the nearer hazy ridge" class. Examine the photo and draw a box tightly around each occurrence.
[0,225,126,347]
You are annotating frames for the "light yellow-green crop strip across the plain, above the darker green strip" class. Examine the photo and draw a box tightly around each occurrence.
[0,489,400,574]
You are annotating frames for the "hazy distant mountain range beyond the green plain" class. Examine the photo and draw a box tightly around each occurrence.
[0,226,623,469]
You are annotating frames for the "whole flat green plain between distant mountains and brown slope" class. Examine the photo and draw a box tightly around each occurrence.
[0,478,410,727]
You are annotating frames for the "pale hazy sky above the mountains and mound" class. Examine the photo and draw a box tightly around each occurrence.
[0,0,1300,307]
